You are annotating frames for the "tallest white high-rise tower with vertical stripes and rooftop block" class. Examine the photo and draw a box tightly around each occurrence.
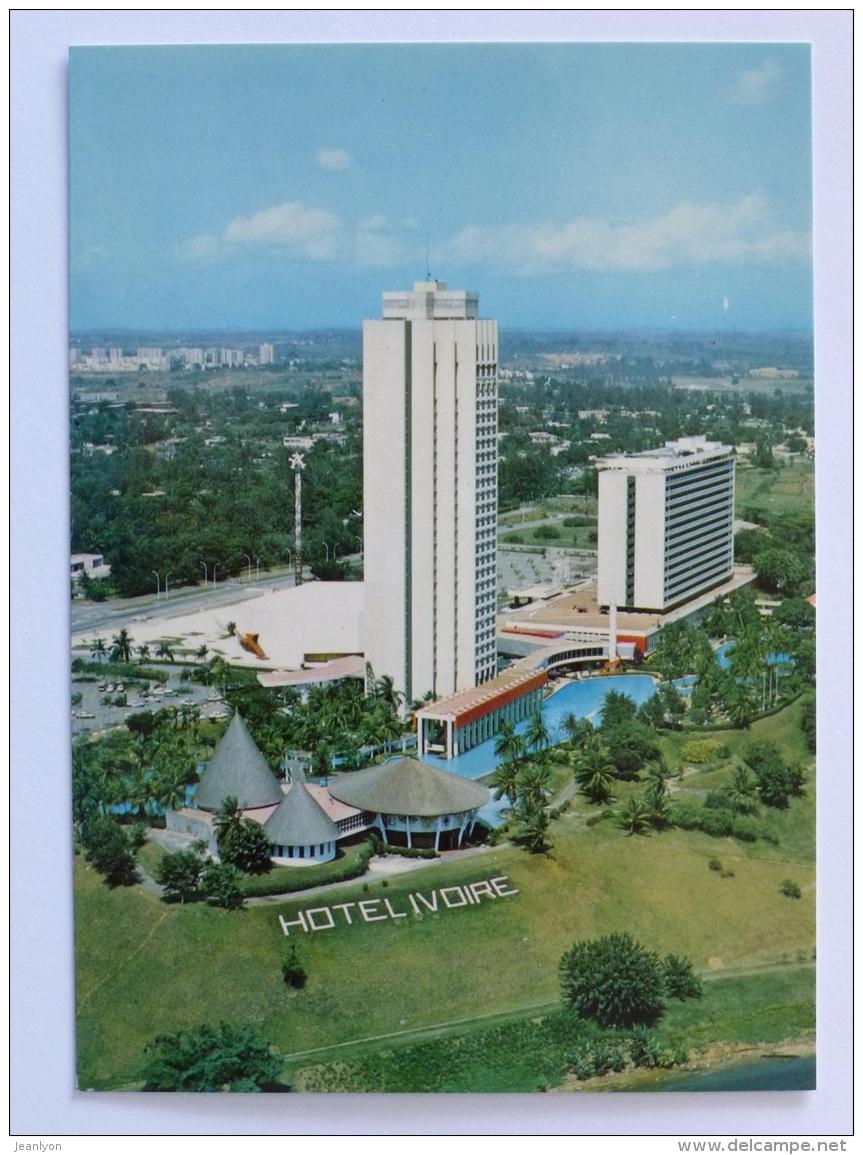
[363,281,498,701]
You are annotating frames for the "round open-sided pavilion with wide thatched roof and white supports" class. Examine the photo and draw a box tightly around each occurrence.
[329,758,490,850]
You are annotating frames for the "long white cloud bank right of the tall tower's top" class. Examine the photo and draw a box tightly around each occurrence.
[445,195,810,275]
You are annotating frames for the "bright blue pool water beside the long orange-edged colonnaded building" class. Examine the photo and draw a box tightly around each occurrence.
[423,673,656,799]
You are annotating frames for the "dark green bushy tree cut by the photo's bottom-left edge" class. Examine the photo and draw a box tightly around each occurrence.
[142,1022,283,1091]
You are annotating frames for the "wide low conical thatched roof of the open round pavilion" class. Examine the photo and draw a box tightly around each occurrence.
[328,758,490,818]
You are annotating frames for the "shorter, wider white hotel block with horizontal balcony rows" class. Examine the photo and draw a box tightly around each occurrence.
[596,437,734,610]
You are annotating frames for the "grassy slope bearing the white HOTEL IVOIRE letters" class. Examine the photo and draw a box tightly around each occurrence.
[76,693,814,1088]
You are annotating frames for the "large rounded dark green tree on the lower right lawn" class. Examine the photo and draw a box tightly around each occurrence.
[559,932,665,1027]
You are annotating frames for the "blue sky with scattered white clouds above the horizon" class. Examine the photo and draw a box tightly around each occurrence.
[69,44,812,331]
